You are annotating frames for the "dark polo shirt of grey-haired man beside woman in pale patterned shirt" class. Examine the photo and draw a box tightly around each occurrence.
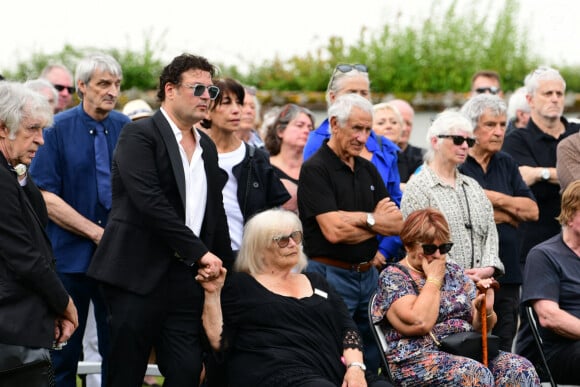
[459,152,535,284]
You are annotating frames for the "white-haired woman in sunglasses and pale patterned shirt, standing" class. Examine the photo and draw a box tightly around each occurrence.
[401,110,504,282]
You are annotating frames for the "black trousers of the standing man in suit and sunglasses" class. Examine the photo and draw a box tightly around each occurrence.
[103,262,203,387]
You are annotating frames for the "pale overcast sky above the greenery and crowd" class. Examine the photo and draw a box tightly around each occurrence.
[0,0,580,71]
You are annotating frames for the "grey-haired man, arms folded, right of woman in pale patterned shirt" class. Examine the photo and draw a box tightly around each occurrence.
[459,93,538,352]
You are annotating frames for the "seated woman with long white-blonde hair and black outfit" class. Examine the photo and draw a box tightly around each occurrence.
[196,209,390,387]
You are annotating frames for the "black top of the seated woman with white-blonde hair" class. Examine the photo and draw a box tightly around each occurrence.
[221,273,360,387]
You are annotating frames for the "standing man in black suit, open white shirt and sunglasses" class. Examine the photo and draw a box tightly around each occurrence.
[88,54,232,387]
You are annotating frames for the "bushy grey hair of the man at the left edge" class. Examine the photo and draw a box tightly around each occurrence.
[0,81,53,140]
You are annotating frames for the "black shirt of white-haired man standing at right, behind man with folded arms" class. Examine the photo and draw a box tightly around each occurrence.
[502,117,580,263]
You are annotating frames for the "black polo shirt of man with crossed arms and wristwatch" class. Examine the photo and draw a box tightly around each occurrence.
[298,140,389,263]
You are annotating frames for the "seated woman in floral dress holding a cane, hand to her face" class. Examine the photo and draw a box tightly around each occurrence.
[372,208,540,386]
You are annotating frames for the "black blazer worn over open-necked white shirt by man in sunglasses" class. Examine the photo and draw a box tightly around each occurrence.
[87,111,233,295]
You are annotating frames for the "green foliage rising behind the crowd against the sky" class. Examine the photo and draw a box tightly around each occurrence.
[4,0,580,94]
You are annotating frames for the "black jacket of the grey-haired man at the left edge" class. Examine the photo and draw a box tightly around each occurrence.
[0,154,69,348]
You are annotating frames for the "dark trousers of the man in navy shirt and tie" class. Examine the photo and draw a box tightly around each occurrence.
[50,273,109,387]
